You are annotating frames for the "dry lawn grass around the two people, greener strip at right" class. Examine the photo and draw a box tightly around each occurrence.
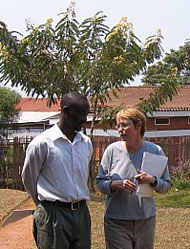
[0,189,190,249]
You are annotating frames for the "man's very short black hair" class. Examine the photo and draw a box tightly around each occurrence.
[60,92,88,108]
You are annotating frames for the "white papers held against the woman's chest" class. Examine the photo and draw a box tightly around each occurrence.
[136,152,168,197]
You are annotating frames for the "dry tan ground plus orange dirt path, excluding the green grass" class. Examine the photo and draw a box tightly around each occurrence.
[0,189,190,249]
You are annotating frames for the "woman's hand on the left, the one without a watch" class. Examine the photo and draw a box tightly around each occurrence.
[111,179,137,193]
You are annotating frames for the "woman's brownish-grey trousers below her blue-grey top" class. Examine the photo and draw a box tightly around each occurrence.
[104,216,156,249]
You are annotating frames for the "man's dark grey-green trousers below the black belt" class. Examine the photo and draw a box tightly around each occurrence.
[33,204,91,249]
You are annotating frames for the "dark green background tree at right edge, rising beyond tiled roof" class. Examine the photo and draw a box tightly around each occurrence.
[142,41,190,85]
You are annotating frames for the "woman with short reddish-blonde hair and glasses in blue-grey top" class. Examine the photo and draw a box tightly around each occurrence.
[97,107,170,249]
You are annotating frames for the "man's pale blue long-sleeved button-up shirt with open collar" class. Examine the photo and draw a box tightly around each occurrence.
[22,125,92,205]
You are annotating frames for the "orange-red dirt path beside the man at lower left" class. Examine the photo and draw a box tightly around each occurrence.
[0,199,35,249]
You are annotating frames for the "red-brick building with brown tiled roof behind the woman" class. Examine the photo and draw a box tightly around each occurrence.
[89,86,190,137]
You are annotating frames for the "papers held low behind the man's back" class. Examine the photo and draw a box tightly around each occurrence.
[2,209,34,226]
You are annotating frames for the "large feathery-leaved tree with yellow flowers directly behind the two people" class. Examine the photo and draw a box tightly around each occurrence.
[0,2,176,135]
